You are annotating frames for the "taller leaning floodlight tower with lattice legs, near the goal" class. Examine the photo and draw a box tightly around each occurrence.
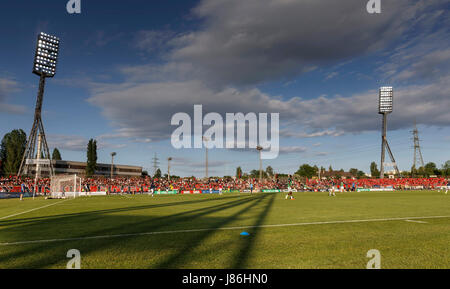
[18,32,59,176]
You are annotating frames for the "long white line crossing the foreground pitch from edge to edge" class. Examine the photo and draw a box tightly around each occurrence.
[0,216,450,246]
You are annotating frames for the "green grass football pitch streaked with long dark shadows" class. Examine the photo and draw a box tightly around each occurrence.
[0,191,450,269]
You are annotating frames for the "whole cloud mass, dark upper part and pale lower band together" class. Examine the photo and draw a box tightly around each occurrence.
[85,0,450,141]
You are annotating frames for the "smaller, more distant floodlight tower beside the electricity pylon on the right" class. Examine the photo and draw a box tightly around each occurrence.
[378,86,400,179]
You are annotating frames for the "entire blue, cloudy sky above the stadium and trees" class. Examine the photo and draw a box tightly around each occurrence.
[0,0,450,176]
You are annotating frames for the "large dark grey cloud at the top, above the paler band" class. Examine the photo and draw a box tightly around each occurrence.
[163,0,434,85]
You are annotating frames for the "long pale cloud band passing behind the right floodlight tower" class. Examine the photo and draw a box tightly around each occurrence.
[89,76,450,140]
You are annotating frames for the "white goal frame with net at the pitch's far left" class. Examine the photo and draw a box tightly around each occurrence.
[50,175,81,199]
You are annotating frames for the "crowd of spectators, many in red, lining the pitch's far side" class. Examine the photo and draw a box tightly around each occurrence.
[0,176,450,194]
